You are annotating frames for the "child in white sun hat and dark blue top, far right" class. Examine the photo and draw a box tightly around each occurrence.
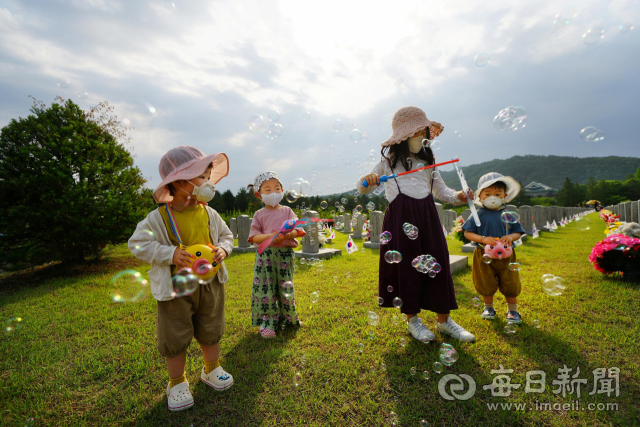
[462,172,525,323]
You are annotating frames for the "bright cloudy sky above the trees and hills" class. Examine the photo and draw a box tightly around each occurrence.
[0,0,640,197]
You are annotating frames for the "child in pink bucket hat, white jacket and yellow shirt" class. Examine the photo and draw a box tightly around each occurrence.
[129,146,233,411]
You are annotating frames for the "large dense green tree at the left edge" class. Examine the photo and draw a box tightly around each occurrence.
[0,98,155,268]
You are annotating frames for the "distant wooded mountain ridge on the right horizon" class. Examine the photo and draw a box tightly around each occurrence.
[438,155,640,190]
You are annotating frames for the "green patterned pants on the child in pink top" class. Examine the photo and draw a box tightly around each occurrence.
[251,248,300,330]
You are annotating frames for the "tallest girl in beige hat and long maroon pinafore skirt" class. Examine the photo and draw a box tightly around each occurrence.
[358,107,474,341]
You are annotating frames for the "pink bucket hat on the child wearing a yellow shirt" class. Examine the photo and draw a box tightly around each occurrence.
[153,145,229,203]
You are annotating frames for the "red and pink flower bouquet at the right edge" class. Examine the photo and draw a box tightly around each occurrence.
[589,234,640,281]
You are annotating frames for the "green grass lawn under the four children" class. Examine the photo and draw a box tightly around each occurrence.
[0,214,640,426]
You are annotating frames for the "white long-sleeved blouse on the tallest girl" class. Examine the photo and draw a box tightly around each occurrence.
[357,154,465,206]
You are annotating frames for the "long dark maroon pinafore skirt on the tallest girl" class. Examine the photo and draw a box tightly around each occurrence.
[378,193,458,314]
